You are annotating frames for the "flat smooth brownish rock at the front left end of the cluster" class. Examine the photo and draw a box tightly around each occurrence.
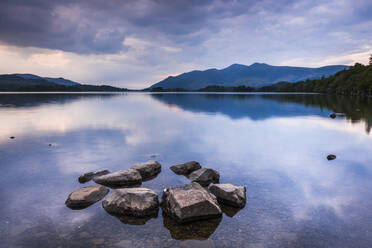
[65,185,109,209]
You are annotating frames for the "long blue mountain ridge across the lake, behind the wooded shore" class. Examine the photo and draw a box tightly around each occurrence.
[150,63,348,90]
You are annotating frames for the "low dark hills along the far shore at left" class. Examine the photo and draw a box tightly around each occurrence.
[0,74,127,92]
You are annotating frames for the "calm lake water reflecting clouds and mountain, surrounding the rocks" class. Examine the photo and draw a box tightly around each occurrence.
[0,94,372,248]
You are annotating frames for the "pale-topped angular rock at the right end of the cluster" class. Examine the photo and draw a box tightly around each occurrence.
[208,183,247,208]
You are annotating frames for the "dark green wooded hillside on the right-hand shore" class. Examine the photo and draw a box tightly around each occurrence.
[259,63,372,95]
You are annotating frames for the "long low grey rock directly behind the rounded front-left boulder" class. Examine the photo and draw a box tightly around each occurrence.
[93,169,142,188]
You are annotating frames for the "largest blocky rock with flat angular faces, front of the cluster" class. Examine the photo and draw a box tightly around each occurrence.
[162,182,222,223]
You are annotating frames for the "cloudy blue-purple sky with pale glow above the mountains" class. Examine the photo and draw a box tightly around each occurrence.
[0,0,372,89]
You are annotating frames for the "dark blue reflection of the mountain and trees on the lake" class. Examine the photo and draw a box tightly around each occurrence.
[152,94,372,133]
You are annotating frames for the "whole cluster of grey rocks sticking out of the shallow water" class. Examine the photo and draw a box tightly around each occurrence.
[66,160,246,224]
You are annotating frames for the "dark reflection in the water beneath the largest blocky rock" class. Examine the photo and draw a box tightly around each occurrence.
[163,213,222,240]
